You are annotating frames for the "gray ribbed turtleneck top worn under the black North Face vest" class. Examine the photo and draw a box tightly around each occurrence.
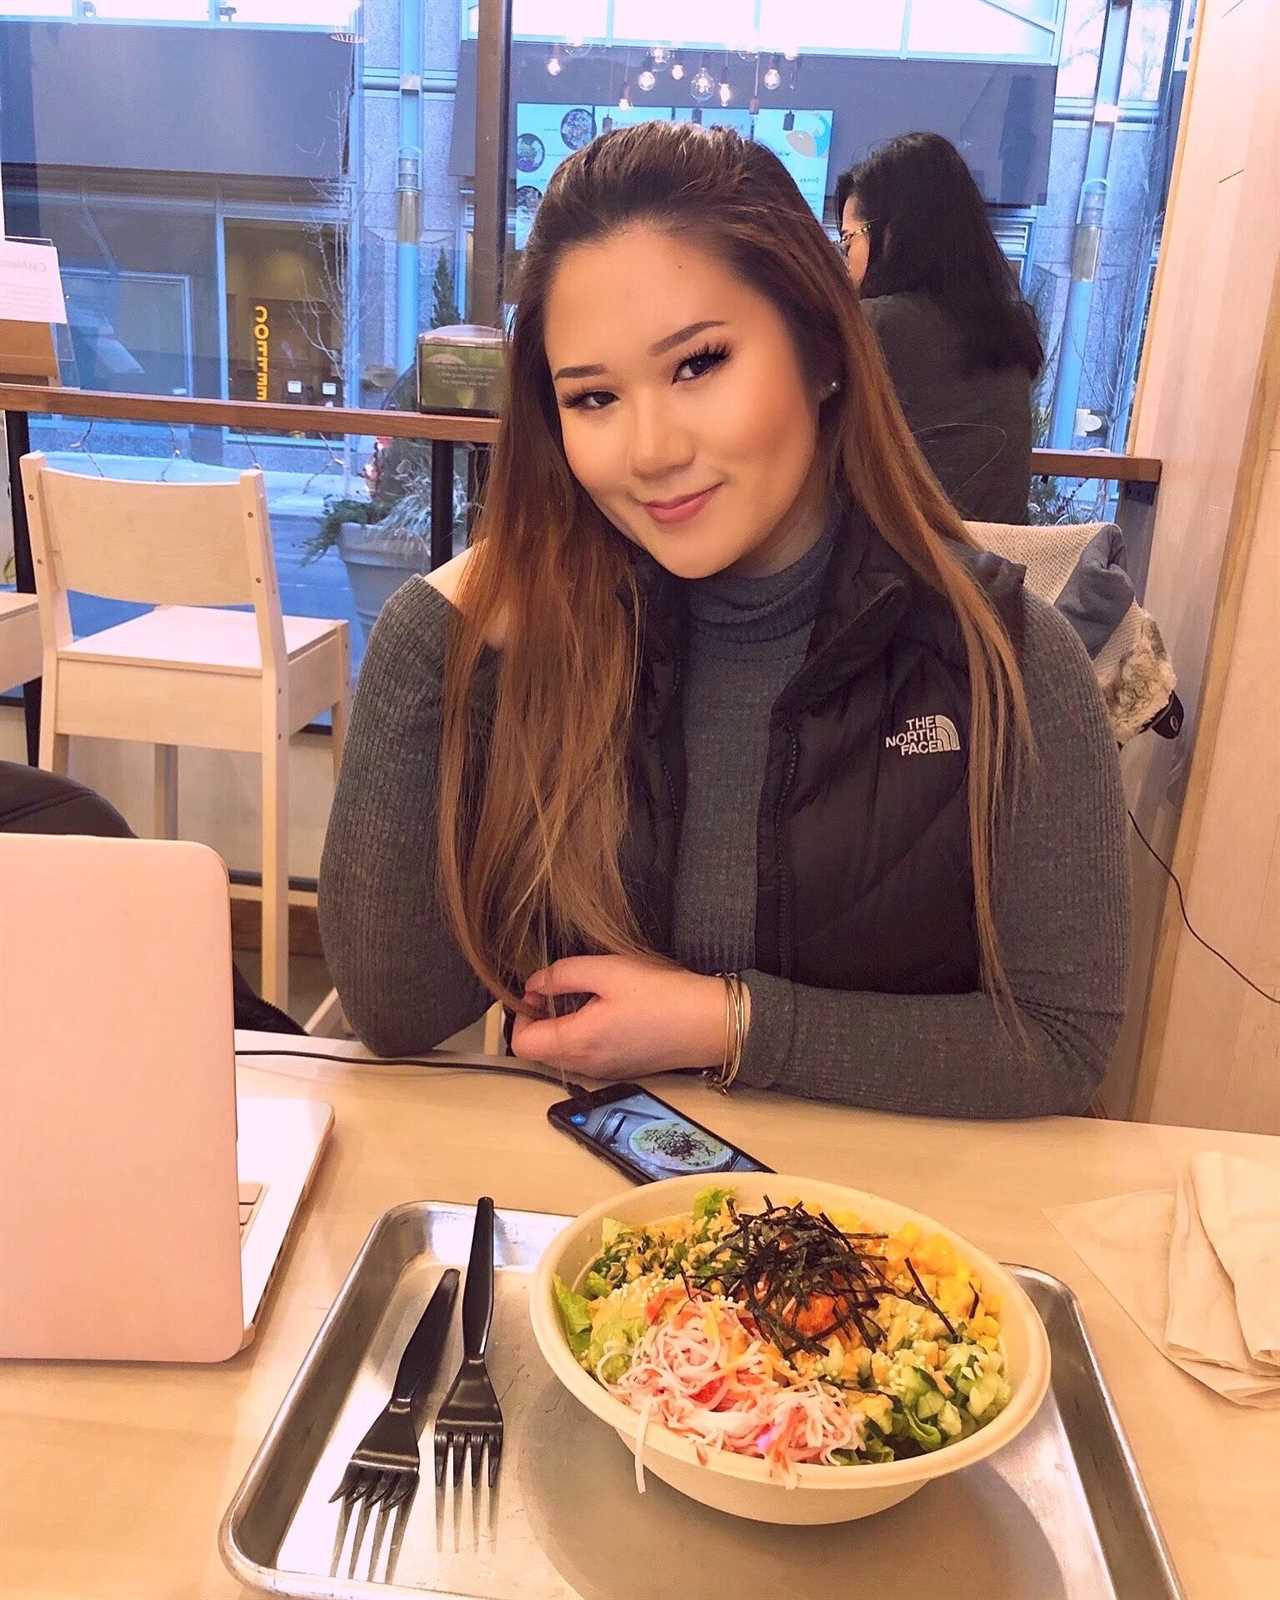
[320,538,1128,1117]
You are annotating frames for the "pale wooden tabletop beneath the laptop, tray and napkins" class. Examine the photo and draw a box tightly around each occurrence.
[0,1035,1280,1600]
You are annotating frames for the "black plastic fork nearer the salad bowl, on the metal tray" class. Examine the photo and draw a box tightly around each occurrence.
[435,1197,502,1490]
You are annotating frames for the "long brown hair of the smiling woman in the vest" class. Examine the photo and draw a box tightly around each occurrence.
[438,123,1029,1005]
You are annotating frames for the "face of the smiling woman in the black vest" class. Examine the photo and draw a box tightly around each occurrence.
[546,226,826,578]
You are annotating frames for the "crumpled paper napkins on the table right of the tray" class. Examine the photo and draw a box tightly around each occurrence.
[1045,1150,1280,1406]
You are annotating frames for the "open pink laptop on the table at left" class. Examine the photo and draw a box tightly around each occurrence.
[0,834,333,1362]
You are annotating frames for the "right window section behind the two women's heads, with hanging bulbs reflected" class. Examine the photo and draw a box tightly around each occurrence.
[496,0,1190,492]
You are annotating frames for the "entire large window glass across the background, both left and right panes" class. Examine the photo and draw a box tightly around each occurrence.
[0,0,1194,653]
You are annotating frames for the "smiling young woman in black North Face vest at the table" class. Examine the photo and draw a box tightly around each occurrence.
[320,123,1128,1117]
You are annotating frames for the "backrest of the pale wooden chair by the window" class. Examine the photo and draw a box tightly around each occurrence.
[22,451,283,664]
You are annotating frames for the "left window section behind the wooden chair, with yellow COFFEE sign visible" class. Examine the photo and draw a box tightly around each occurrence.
[0,0,474,659]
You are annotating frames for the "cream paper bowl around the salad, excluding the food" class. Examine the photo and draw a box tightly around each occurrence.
[530,1173,1050,1525]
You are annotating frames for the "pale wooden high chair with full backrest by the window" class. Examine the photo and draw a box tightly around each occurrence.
[22,454,350,1008]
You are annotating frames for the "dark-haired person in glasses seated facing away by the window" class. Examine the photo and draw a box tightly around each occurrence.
[835,133,1045,523]
